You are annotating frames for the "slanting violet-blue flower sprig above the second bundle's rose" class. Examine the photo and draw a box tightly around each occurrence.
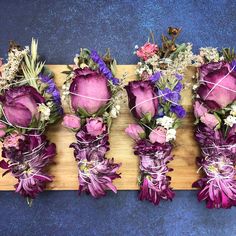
[90,50,119,85]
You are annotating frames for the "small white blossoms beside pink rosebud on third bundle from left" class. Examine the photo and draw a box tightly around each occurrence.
[156,116,176,142]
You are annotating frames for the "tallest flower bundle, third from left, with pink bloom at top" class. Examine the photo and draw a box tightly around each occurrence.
[125,27,192,204]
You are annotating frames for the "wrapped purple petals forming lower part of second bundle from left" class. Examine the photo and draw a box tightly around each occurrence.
[70,127,120,198]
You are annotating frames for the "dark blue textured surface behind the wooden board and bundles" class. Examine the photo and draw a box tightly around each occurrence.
[0,0,236,236]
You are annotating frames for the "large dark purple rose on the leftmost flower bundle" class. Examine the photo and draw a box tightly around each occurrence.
[0,86,45,127]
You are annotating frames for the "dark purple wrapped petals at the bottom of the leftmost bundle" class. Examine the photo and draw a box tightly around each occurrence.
[0,133,56,199]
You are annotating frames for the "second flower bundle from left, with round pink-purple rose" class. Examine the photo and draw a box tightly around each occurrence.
[62,49,123,198]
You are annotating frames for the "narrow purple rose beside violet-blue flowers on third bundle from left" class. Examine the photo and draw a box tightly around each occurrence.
[125,80,158,119]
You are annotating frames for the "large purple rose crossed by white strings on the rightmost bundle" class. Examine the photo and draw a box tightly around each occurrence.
[197,62,236,109]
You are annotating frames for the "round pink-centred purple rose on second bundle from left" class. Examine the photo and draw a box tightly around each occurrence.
[70,67,111,114]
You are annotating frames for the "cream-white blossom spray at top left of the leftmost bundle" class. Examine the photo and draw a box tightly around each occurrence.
[0,47,29,88]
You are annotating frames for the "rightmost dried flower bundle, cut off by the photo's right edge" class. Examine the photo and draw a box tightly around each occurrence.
[193,48,236,208]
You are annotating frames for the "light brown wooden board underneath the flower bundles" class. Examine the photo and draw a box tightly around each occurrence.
[0,65,199,190]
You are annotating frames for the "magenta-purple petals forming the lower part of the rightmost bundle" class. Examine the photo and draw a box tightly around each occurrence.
[193,124,236,208]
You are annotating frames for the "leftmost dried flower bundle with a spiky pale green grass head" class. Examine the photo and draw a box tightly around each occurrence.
[0,39,63,203]
